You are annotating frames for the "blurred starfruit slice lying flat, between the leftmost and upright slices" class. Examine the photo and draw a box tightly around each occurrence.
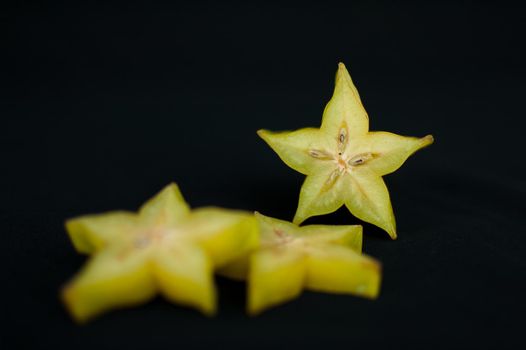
[219,213,381,314]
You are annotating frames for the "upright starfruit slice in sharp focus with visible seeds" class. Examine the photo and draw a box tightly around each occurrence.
[258,63,433,239]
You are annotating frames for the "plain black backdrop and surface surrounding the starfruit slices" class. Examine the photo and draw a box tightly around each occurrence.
[0,1,526,349]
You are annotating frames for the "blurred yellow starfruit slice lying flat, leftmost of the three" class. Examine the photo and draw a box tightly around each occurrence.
[61,184,258,322]
